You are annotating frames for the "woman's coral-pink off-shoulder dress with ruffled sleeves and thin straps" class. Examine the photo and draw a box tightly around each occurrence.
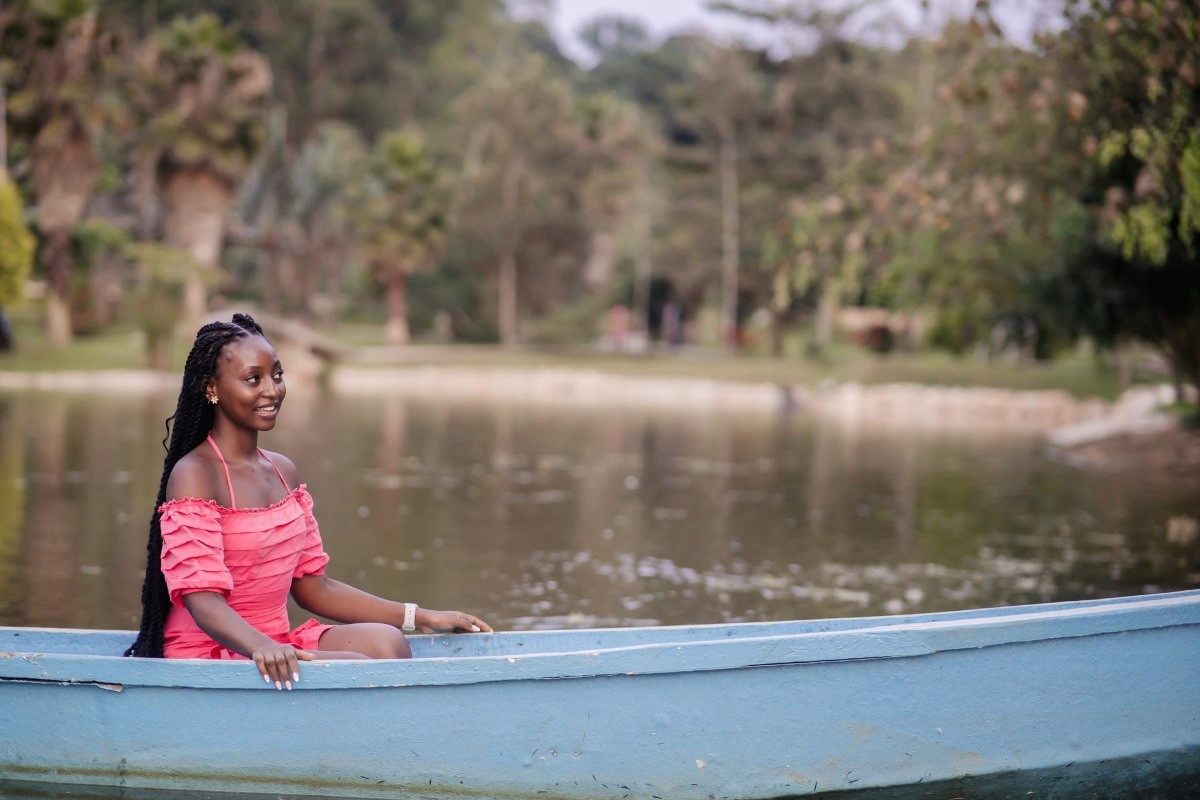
[161,437,332,658]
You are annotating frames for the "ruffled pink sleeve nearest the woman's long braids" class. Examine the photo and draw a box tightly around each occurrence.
[161,498,233,606]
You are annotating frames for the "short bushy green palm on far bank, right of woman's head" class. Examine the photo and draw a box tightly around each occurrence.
[354,131,448,344]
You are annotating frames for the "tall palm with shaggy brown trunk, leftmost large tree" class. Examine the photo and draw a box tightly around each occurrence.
[0,0,119,347]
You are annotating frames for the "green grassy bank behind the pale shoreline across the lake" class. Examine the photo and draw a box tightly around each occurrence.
[0,317,1142,399]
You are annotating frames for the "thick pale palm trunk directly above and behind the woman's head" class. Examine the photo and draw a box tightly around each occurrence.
[163,169,234,318]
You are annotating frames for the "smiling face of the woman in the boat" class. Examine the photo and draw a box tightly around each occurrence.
[209,336,288,431]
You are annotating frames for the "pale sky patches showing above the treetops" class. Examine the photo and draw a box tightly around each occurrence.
[535,0,1045,62]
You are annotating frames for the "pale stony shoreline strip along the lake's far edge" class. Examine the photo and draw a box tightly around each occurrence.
[0,365,1152,431]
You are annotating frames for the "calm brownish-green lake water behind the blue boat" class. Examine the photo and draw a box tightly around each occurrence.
[0,387,1200,630]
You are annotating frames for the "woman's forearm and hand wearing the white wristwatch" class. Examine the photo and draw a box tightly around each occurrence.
[292,575,492,633]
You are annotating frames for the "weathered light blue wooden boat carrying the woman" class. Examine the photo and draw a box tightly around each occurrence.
[0,591,1200,800]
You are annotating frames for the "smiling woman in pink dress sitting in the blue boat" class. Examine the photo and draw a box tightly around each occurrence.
[125,314,492,688]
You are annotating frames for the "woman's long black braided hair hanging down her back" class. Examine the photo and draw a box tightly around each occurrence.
[125,314,265,658]
